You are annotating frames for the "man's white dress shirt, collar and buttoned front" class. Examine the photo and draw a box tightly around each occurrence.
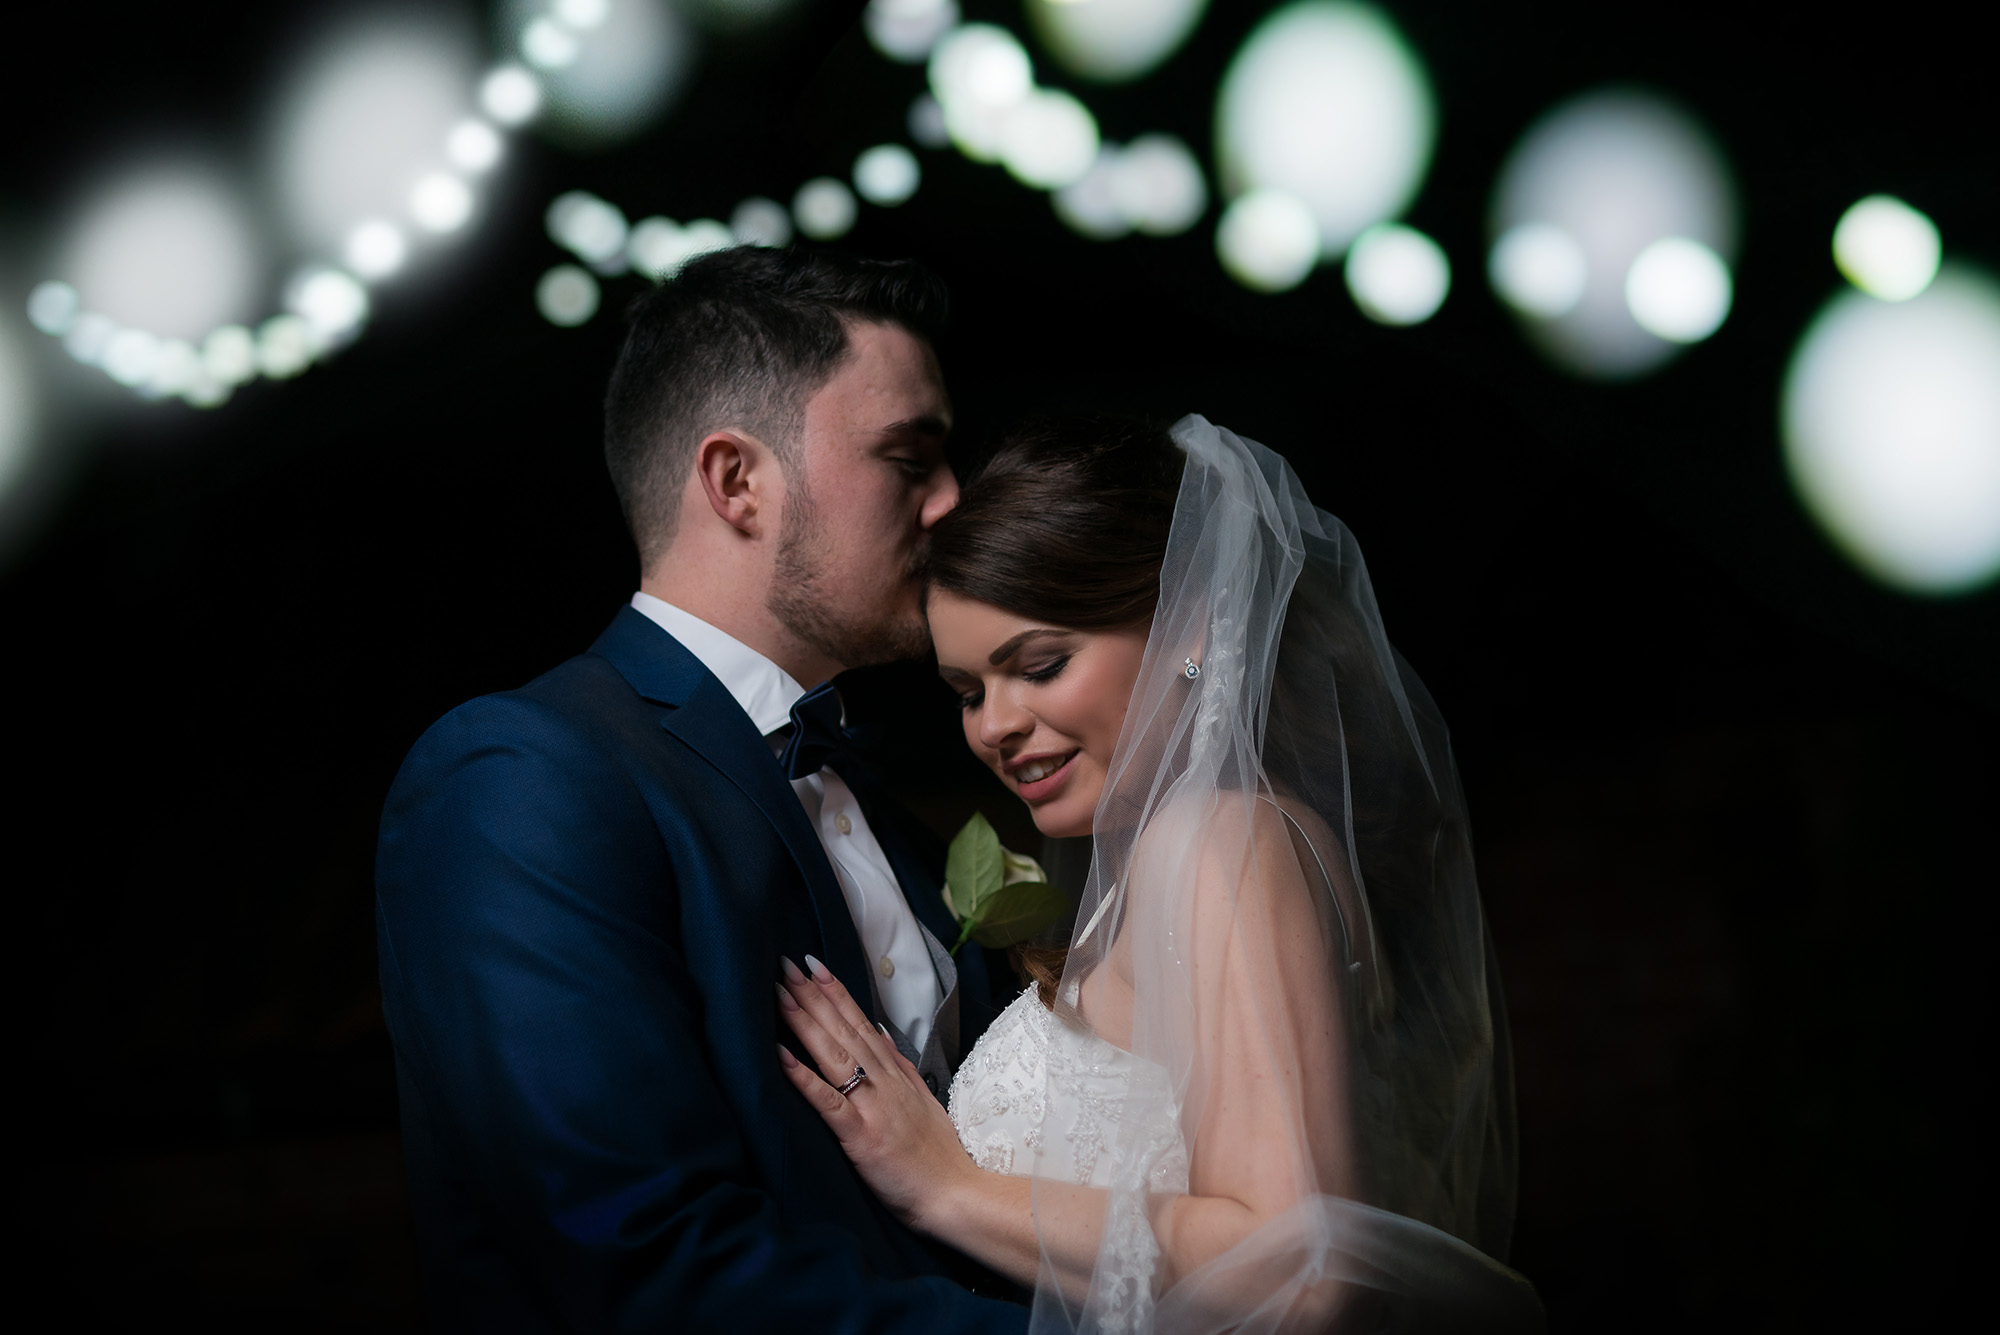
[632,594,944,1051]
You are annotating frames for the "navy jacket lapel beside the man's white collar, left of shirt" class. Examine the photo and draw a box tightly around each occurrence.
[592,608,880,1019]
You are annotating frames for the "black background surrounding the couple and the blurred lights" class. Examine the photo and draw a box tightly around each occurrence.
[0,0,2000,1331]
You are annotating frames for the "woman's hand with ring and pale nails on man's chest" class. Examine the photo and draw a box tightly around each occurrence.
[778,955,978,1229]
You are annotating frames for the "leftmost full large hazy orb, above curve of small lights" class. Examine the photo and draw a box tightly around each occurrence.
[58,162,264,338]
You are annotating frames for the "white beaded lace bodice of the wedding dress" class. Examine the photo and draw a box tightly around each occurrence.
[950,987,1188,1191]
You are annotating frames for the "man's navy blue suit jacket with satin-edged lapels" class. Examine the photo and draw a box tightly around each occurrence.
[376,608,1028,1335]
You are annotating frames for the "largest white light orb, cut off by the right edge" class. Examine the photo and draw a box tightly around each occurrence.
[1784,266,2000,594]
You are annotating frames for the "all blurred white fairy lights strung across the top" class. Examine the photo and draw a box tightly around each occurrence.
[0,0,2000,594]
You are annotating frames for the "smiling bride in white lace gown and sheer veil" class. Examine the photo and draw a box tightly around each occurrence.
[780,418,1542,1333]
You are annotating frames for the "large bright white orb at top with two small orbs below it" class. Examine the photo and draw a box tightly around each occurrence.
[1216,0,1436,256]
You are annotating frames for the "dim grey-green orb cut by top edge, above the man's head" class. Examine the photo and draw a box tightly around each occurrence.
[500,0,694,146]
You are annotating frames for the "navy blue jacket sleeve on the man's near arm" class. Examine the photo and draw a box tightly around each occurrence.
[376,697,1026,1333]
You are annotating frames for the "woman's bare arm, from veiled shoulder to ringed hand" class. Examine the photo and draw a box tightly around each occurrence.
[780,801,1350,1291]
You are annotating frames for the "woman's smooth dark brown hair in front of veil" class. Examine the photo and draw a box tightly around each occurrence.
[924,416,1186,1007]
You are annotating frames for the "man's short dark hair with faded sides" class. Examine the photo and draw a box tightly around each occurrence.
[604,246,946,570]
